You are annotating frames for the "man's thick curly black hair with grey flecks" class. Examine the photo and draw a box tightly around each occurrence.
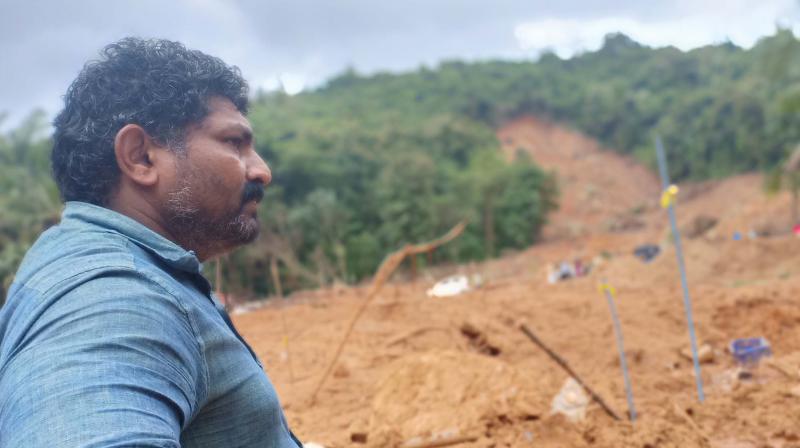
[51,37,248,205]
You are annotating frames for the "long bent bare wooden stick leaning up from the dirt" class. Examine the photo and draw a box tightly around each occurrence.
[311,222,467,405]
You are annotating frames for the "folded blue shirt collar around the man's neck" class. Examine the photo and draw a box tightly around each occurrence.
[61,201,202,274]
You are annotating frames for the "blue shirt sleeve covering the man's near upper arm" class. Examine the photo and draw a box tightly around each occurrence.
[0,271,205,448]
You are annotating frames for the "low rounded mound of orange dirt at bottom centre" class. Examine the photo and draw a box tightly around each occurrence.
[370,351,550,447]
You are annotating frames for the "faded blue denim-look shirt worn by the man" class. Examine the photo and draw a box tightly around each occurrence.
[0,202,300,448]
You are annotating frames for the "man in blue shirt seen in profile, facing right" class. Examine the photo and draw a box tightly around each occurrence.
[0,38,301,448]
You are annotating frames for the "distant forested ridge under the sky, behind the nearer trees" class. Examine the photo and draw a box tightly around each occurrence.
[276,30,800,179]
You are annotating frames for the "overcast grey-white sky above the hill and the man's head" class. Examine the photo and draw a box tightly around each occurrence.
[0,0,800,129]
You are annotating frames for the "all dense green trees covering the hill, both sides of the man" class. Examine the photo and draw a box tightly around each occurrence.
[0,30,800,295]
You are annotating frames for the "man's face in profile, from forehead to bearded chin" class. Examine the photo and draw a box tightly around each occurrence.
[164,97,272,258]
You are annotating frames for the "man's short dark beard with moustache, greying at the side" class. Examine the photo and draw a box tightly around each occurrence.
[166,176,264,255]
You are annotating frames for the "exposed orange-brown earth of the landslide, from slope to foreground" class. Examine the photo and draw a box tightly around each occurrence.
[234,118,800,448]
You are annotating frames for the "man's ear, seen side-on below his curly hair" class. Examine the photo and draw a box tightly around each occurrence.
[114,124,163,187]
